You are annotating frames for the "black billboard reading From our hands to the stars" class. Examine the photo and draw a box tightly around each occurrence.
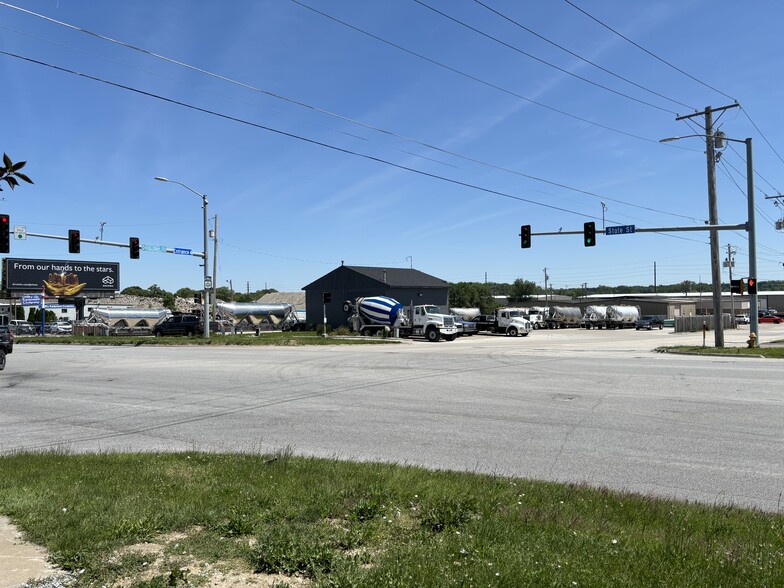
[3,257,120,297]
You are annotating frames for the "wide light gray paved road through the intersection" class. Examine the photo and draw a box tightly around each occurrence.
[0,325,784,511]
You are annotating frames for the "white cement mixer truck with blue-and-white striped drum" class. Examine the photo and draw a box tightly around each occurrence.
[343,296,457,341]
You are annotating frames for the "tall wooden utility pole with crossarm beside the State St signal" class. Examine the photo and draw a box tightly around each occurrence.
[675,102,739,347]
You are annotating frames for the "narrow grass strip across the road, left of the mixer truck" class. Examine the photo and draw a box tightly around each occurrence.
[14,331,397,347]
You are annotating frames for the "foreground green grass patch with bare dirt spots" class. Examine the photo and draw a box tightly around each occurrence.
[0,452,784,588]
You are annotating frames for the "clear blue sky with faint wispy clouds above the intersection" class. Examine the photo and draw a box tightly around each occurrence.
[0,0,784,291]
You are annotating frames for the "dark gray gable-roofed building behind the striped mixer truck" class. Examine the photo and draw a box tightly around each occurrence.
[302,265,449,327]
